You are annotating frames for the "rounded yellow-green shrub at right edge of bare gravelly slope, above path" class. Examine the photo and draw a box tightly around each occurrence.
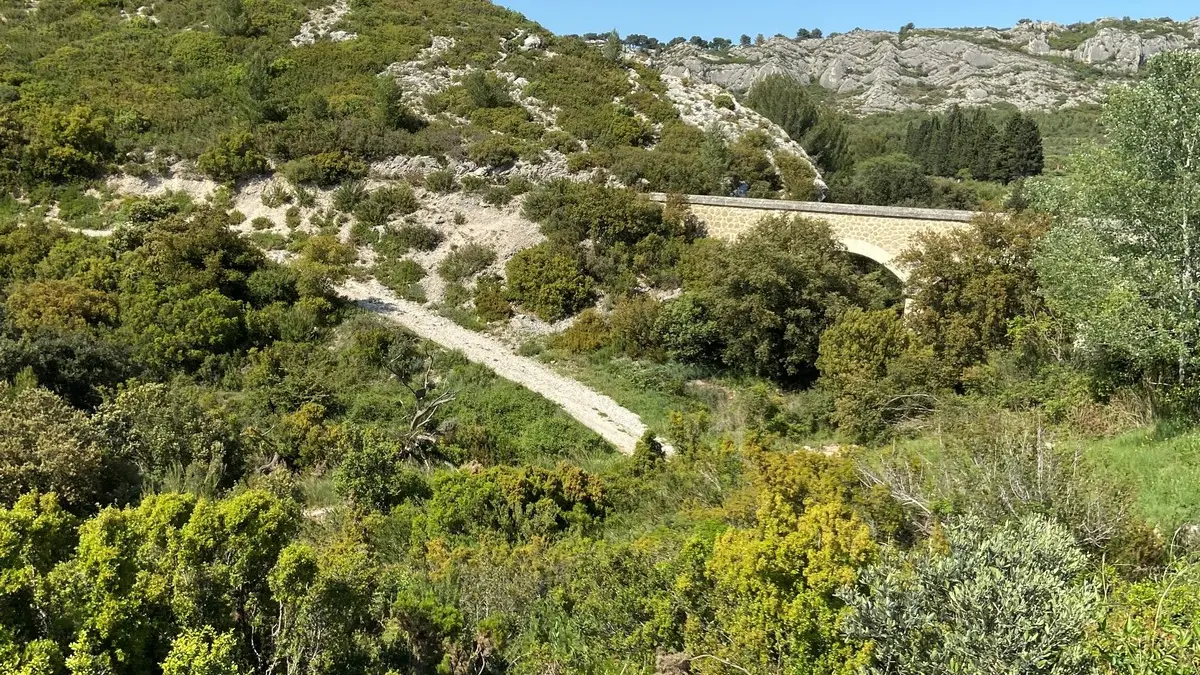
[506,241,593,321]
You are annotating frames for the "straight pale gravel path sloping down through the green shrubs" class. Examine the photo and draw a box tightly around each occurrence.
[338,280,671,454]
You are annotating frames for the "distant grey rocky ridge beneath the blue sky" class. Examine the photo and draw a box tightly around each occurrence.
[655,18,1200,114]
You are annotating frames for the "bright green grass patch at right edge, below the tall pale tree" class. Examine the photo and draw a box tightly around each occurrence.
[1087,429,1200,537]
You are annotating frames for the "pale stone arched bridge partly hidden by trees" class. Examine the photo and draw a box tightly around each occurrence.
[650,193,976,281]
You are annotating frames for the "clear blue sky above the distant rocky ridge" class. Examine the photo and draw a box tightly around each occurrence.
[496,0,1200,40]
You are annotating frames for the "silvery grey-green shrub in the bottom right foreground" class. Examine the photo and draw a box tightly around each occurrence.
[844,516,1099,673]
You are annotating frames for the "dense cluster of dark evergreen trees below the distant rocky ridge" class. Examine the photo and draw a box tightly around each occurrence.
[905,107,1045,183]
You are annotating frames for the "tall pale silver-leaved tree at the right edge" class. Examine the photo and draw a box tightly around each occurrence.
[1031,53,1200,389]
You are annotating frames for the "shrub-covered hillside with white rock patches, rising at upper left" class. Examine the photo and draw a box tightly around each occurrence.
[0,0,812,191]
